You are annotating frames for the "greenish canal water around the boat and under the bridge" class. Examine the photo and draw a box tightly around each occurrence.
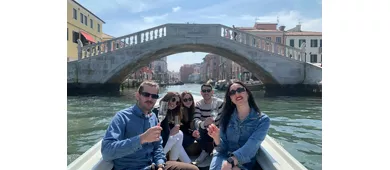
[67,84,322,170]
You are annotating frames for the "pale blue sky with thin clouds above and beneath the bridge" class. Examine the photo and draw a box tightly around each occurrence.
[77,0,322,71]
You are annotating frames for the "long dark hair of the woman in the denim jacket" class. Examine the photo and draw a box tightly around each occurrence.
[220,81,261,132]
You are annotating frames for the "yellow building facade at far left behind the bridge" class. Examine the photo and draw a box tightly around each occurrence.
[67,0,105,61]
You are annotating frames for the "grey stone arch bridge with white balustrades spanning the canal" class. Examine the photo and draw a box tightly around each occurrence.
[67,24,322,94]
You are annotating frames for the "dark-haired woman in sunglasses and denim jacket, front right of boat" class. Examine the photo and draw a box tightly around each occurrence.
[207,82,270,170]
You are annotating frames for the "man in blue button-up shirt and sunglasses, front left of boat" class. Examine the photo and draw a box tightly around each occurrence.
[101,81,198,170]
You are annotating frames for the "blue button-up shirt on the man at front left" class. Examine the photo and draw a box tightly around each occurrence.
[101,105,166,170]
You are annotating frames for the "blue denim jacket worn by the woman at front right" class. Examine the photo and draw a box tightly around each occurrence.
[215,108,270,165]
